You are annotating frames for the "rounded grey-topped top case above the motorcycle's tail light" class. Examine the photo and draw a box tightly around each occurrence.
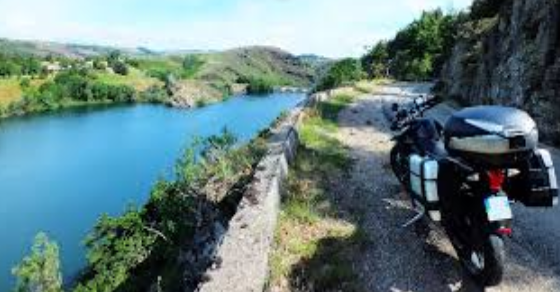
[444,106,538,167]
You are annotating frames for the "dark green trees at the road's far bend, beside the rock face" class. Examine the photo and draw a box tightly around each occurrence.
[315,7,470,91]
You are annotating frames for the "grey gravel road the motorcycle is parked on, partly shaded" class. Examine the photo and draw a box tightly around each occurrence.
[339,84,560,292]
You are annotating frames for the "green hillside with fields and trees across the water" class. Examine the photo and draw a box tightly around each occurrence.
[0,39,322,116]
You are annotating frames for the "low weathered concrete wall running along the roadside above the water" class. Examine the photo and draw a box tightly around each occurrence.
[199,93,329,292]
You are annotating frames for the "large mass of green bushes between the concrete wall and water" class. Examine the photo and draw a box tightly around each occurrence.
[69,129,264,292]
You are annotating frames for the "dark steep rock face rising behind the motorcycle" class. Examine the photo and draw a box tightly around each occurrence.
[441,0,560,144]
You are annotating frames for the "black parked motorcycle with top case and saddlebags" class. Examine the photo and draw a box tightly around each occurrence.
[391,97,558,286]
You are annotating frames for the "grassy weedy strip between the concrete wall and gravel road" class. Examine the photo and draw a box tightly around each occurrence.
[269,94,368,291]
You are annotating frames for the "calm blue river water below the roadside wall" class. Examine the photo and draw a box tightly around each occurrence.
[0,94,303,291]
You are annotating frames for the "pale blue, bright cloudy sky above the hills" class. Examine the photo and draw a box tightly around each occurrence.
[0,0,472,58]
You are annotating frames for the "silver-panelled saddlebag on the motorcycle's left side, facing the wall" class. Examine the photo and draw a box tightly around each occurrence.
[409,154,441,222]
